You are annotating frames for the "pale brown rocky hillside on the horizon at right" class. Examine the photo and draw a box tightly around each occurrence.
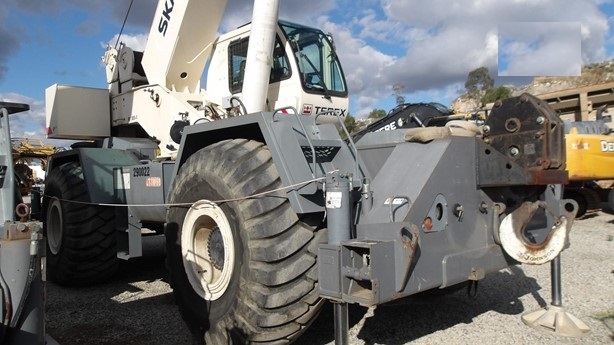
[450,60,614,112]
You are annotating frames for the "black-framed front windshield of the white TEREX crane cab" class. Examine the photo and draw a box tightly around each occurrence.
[279,22,347,96]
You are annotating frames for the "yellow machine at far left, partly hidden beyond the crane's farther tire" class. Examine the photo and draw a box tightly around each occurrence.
[11,138,58,196]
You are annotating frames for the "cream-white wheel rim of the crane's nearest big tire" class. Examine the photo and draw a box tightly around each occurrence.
[181,200,235,301]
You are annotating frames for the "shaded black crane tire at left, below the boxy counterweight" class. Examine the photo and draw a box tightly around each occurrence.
[43,162,119,285]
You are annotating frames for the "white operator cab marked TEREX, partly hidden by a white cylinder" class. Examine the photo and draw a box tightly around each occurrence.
[207,21,348,117]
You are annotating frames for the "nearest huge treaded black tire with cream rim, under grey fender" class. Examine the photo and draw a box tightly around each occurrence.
[166,139,326,345]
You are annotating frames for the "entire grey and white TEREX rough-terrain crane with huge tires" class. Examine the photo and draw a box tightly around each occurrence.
[43,0,588,344]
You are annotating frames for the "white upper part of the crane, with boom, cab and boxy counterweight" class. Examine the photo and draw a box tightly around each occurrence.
[47,0,348,159]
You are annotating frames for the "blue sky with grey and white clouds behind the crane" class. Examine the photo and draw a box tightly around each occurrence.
[0,0,614,143]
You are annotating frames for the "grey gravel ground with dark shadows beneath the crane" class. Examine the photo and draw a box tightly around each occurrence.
[47,206,614,345]
